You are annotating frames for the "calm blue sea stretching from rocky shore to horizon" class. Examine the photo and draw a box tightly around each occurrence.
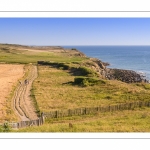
[63,46,150,80]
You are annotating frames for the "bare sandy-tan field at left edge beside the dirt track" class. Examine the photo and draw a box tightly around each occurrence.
[0,64,24,117]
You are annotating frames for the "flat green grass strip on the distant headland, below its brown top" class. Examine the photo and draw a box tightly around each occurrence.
[0,50,85,64]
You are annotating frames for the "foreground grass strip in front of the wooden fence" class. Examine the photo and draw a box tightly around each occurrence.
[13,108,150,133]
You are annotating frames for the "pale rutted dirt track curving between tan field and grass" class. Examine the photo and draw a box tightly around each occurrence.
[13,65,38,121]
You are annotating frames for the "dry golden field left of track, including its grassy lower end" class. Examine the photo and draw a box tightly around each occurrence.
[0,64,24,122]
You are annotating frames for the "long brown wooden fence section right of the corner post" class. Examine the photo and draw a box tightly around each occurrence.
[43,101,150,118]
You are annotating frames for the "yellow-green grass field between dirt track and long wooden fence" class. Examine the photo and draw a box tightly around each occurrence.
[33,66,150,112]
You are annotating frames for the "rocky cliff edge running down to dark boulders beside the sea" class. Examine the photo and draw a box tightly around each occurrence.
[65,48,150,83]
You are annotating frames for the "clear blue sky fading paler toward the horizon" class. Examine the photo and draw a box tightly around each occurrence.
[0,18,150,46]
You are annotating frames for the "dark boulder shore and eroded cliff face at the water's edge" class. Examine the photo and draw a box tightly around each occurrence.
[72,48,150,83]
